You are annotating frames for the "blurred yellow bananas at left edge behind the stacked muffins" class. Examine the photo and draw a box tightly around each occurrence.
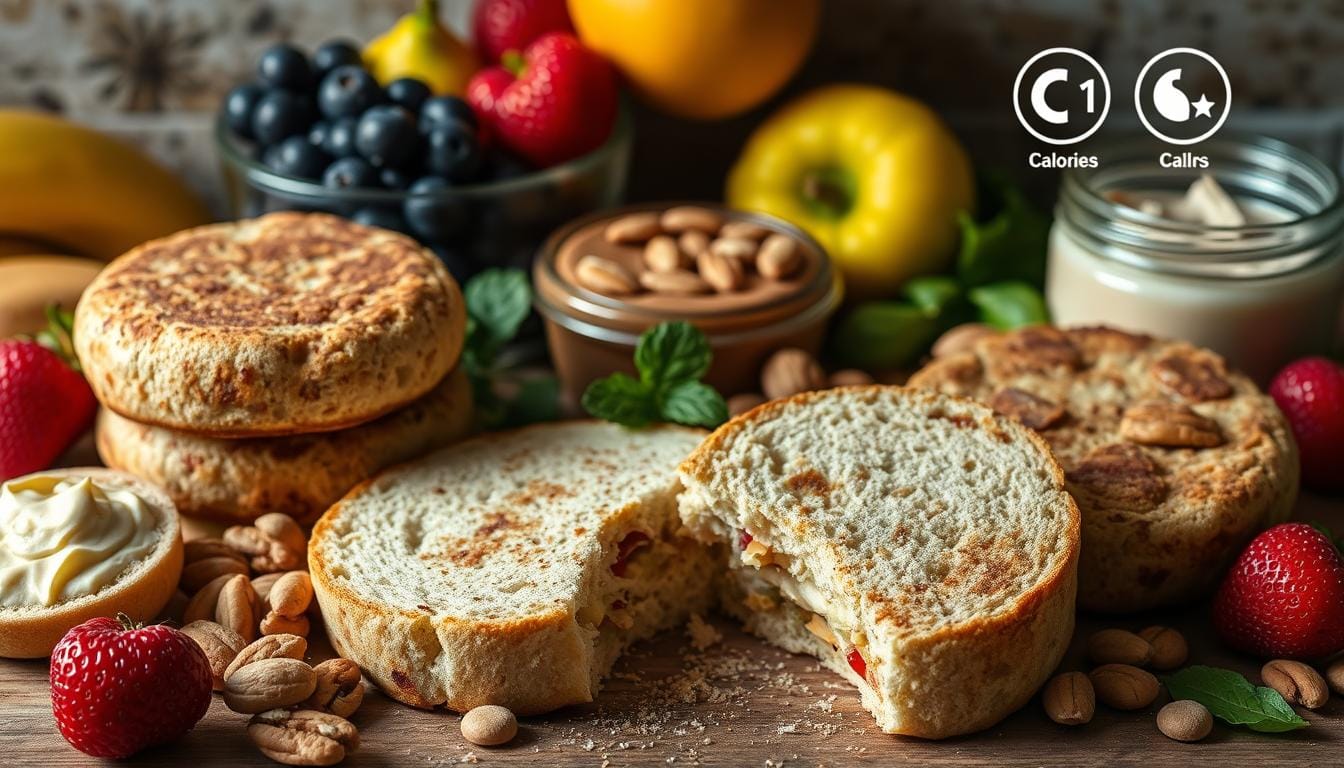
[0,109,210,339]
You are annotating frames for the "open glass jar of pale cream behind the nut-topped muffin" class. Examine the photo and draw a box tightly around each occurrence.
[1046,137,1344,382]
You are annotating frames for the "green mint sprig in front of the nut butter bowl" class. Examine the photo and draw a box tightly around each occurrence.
[581,321,728,429]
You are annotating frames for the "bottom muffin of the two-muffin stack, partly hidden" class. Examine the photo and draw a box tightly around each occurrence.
[97,369,474,525]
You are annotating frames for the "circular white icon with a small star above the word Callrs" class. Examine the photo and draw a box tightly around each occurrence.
[1134,48,1232,145]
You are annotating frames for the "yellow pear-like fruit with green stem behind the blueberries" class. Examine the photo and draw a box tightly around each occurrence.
[364,0,480,95]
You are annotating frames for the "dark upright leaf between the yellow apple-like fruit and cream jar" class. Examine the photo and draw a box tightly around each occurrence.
[957,178,1050,286]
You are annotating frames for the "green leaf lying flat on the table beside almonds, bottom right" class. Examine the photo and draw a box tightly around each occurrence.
[1163,666,1310,733]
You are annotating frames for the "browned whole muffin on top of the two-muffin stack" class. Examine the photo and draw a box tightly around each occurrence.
[74,213,465,437]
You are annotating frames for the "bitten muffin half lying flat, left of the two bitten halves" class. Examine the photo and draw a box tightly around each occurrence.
[308,421,716,714]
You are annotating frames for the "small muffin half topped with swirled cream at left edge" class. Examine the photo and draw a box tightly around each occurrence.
[0,467,183,659]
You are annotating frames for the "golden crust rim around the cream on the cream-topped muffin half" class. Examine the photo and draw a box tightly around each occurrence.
[0,467,183,659]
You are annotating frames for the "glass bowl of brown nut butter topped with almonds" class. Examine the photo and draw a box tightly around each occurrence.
[532,203,841,397]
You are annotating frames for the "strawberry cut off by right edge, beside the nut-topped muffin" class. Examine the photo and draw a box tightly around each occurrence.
[1269,358,1344,491]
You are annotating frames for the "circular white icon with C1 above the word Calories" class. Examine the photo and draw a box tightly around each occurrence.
[1012,47,1110,145]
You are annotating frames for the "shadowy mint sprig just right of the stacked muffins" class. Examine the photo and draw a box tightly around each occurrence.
[462,269,560,429]
